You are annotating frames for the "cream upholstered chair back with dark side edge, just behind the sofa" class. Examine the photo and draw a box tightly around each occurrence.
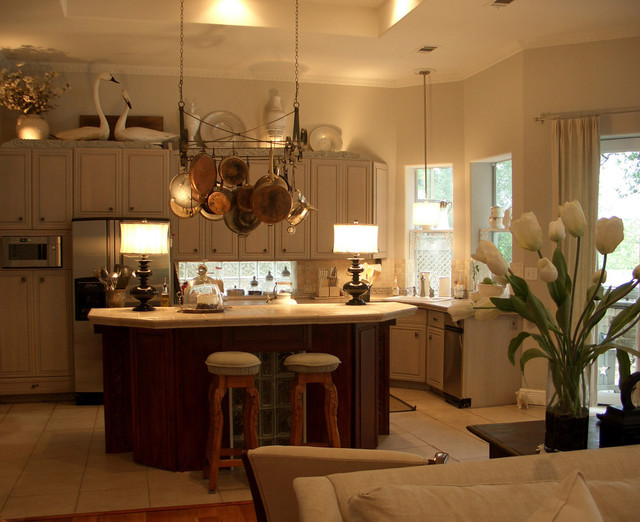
[243,446,436,522]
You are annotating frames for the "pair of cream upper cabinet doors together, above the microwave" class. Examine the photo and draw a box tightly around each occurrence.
[0,149,72,229]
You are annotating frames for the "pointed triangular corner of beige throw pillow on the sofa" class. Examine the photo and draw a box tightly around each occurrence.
[527,471,603,522]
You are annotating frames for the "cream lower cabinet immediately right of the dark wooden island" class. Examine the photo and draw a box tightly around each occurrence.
[389,310,427,384]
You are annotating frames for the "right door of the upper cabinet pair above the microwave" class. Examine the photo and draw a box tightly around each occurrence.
[32,150,73,228]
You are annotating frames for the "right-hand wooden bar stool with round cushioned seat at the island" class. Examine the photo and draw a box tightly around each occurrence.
[284,353,340,448]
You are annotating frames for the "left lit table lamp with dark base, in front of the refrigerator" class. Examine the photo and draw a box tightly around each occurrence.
[120,221,169,312]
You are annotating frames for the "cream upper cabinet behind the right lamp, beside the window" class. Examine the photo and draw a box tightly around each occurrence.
[310,159,388,259]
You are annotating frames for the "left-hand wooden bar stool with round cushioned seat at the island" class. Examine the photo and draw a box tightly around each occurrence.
[203,352,260,491]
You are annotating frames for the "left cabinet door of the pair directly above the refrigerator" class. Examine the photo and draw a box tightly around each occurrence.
[73,149,122,218]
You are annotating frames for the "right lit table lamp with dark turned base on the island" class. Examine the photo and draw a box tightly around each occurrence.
[333,221,378,305]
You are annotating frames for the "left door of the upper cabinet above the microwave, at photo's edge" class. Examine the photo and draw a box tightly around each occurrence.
[0,150,31,229]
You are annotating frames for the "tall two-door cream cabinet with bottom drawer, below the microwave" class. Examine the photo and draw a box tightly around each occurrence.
[0,269,73,395]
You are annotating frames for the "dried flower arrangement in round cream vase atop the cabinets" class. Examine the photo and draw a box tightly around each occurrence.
[0,63,69,139]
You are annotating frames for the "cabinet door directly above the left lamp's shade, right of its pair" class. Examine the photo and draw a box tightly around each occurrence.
[122,150,169,218]
